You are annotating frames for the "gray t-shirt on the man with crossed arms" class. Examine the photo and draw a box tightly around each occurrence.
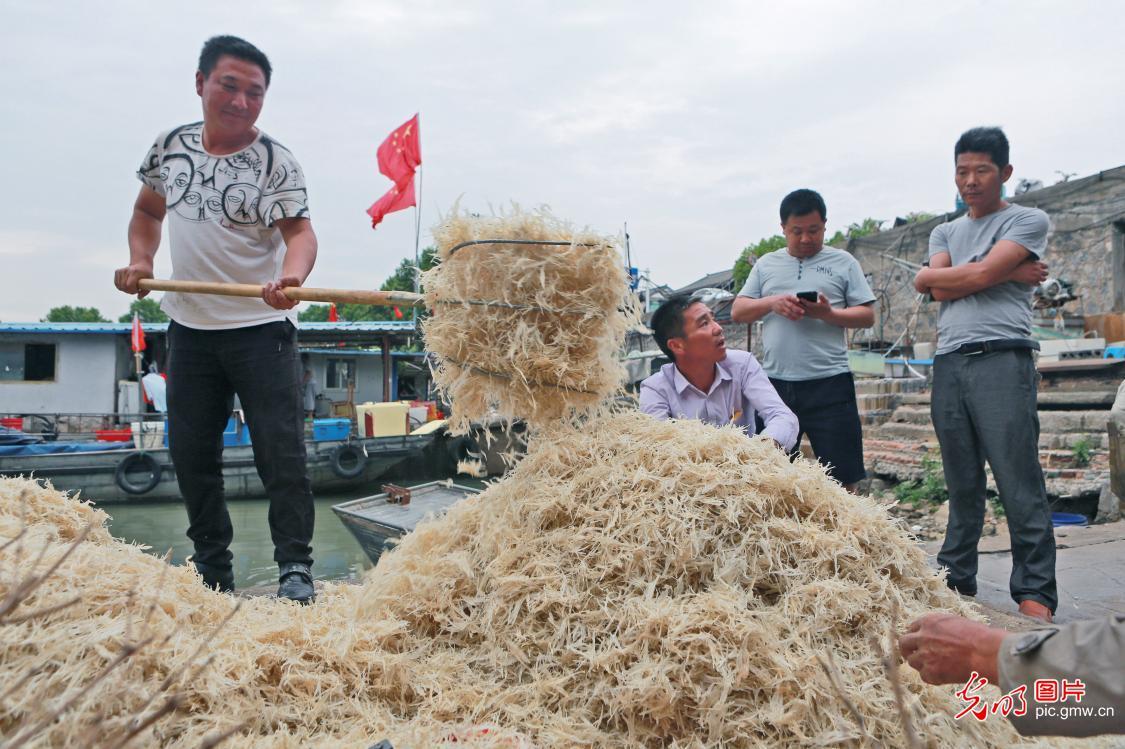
[929,204,1051,354]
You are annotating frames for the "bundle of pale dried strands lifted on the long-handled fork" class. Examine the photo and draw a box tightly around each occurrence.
[422,207,639,433]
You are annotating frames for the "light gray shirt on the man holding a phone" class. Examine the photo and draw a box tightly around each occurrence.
[739,247,875,380]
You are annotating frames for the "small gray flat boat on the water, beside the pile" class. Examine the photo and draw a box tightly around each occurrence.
[332,481,480,563]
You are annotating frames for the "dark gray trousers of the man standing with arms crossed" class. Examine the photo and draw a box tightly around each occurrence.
[930,349,1059,611]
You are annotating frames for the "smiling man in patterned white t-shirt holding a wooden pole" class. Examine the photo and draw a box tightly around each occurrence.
[114,36,316,603]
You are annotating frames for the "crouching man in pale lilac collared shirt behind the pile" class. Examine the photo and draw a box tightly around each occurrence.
[640,295,798,451]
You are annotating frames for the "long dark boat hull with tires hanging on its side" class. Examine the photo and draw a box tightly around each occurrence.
[0,413,438,504]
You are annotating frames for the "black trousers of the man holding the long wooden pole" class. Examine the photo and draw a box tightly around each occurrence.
[168,321,313,569]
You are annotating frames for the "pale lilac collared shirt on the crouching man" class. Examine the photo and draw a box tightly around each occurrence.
[640,350,800,450]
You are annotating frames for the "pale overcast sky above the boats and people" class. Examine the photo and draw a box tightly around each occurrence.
[0,0,1125,322]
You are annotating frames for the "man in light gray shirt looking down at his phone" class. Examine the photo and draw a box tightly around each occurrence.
[731,190,875,491]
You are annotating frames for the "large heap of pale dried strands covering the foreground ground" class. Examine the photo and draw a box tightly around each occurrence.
[0,413,1053,748]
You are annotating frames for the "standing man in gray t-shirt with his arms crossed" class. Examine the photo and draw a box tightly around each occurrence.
[915,127,1059,622]
